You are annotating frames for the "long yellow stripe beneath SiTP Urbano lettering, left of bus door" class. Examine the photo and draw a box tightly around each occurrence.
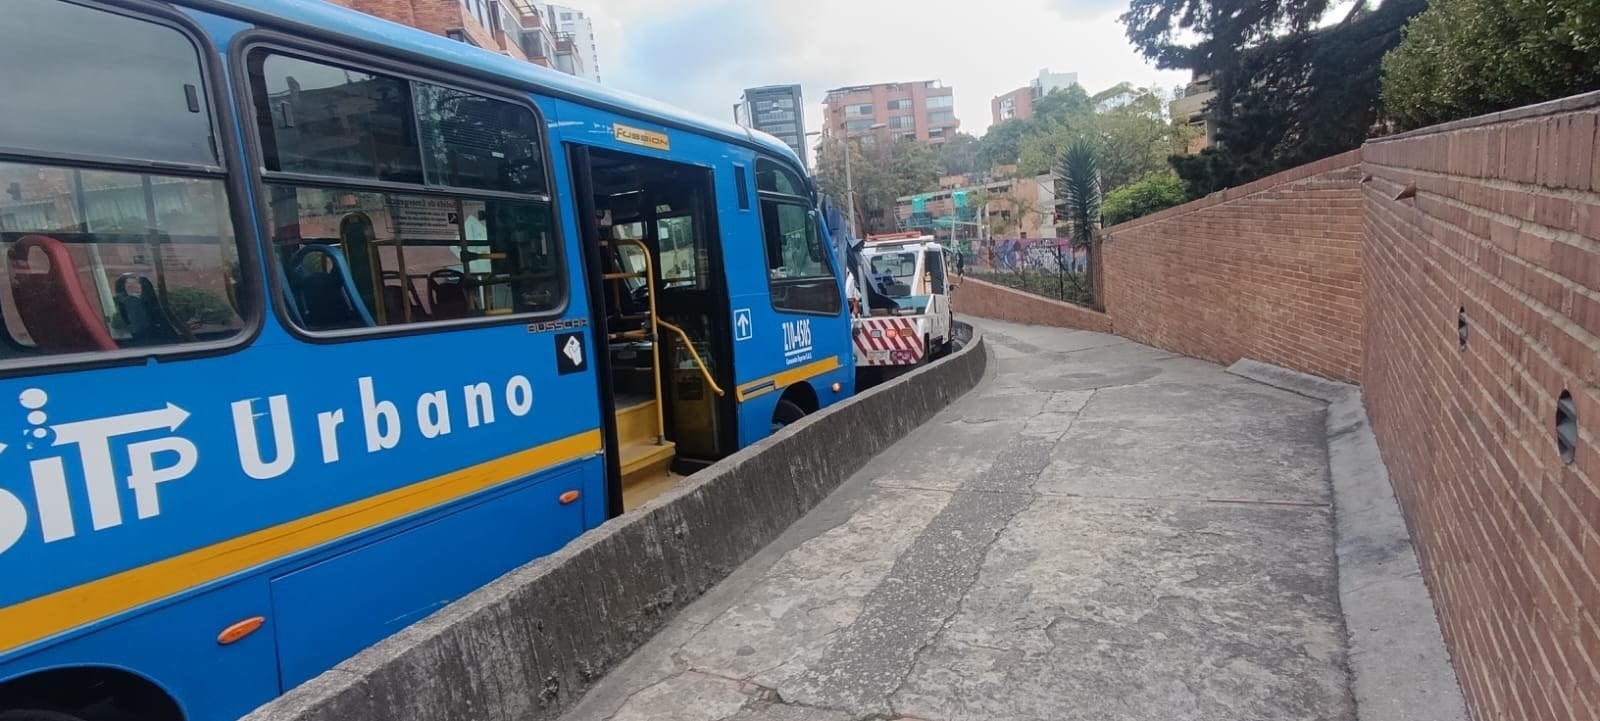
[0,430,600,652]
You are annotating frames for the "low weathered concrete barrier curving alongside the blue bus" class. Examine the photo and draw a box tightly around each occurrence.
[246,326,987,721]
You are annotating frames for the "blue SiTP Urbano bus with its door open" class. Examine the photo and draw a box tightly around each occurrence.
[0,0,854,721]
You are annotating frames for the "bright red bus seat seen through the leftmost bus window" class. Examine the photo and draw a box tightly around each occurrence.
[6,235,117,353]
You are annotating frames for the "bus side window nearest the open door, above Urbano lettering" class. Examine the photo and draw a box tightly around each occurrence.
[250,51,566,331]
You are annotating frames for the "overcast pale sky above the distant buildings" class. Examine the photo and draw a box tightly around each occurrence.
[571,0,1187,147]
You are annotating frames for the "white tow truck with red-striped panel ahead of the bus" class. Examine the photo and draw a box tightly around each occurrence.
[848,232,954,369]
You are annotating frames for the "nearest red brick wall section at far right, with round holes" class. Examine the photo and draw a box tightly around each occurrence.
[1362,94,1600,721]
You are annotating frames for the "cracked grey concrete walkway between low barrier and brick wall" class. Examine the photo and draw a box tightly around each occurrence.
[563,321,1355,721]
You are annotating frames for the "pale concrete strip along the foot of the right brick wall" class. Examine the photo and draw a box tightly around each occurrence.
[1227,364,1467,721]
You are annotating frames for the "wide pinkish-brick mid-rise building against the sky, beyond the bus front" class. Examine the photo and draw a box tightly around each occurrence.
[822,80,962,142]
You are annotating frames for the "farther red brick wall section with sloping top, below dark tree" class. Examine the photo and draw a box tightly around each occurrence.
[1102,152,1362,382]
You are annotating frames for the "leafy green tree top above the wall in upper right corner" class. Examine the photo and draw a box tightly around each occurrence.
[1382,0,1600,128]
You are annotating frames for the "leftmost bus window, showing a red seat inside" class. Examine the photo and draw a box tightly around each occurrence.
[0,0,253,358]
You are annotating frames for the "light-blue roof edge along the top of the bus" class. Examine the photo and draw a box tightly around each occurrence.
[185,0,805,168]
